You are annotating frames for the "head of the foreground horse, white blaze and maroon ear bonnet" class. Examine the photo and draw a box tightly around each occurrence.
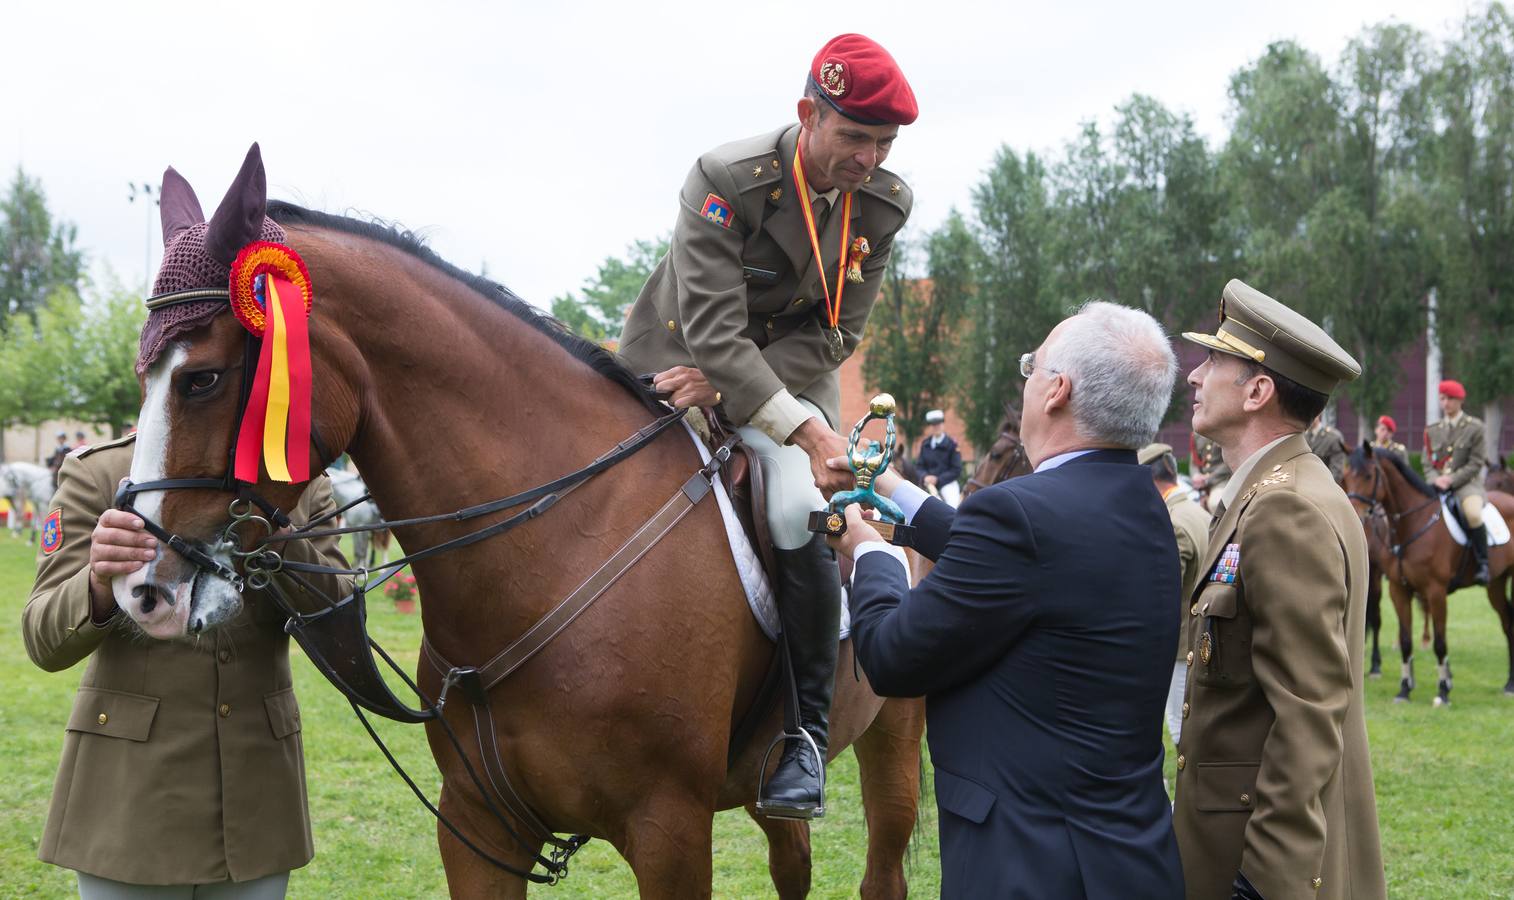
[112,144,334,638]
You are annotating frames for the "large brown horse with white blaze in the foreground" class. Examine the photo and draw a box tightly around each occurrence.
[117,147,924,897]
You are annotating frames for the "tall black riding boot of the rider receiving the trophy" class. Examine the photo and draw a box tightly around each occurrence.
[757,535,842,818]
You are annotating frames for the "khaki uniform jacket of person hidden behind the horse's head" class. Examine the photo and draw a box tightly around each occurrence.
[21,435,348,885]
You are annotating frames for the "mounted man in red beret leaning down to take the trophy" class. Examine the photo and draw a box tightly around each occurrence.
[621,35,917,818]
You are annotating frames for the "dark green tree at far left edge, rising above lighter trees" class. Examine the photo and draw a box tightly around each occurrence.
[0,168,85,323]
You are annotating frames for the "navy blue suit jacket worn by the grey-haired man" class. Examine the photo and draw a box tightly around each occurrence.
[851,450,1182,898]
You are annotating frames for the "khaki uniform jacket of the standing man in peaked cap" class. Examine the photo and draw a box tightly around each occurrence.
[1173,435,1387,900]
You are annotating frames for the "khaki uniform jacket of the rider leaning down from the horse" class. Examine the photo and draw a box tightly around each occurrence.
[619,124,911,429]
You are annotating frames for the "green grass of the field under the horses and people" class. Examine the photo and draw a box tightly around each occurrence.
[0,535,1514,898]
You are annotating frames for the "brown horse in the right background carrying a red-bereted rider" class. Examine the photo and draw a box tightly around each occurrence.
[1346,442,1514,706]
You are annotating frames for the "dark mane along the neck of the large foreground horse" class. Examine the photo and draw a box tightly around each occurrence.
[268,200,668,414]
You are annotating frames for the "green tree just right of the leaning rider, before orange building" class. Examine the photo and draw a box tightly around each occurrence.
[861,219,981,453]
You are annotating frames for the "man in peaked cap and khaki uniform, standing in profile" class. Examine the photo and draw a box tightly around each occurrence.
[1173,280,1387,900]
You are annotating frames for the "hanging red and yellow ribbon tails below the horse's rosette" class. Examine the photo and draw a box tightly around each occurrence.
[235,271,312,483]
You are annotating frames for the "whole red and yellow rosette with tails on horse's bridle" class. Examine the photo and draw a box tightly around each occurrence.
[232,241,315,483]
